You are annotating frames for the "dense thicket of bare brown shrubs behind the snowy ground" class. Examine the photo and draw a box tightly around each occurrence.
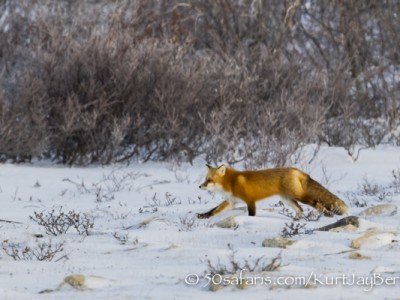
[0,0,400,165]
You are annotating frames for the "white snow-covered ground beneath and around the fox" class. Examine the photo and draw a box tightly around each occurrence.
[0,146,400,299]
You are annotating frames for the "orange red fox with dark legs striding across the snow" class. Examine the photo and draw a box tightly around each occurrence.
[197,165,348,219]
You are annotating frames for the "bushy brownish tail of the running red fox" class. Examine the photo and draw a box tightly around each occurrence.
[305,177,348,215]
